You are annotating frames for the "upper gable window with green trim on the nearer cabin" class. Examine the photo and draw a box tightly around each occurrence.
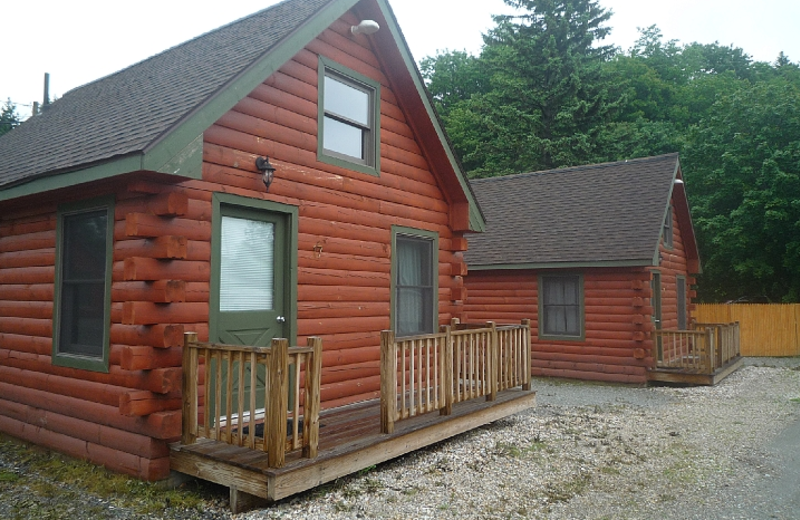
[317,57,380,175]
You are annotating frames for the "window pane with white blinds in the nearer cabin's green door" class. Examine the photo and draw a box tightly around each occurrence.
[219,216,275,312]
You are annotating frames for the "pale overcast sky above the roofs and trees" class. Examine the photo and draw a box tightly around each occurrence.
[6,0,800,115]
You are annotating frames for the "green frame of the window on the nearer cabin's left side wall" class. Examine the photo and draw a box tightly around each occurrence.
[52,195,114,372]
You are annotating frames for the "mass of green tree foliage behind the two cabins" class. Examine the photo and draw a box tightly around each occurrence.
[422,5,800,302]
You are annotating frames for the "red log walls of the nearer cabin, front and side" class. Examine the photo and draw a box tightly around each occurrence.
[0,8,466,479]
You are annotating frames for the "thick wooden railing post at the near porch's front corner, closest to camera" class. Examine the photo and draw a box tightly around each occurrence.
[267,338,289,468]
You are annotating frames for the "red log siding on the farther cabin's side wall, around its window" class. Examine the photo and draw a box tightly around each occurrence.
[464,268,652,384]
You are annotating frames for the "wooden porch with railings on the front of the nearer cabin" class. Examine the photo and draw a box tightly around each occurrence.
[170,321,536,512]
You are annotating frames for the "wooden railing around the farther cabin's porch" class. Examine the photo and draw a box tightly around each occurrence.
[655,322,741,374]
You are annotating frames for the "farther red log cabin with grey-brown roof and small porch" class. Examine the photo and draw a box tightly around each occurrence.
[464,154,739,384]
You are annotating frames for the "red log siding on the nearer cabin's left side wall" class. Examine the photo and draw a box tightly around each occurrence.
[0,186,210,480]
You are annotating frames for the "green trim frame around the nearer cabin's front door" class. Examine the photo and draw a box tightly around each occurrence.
[208,193,299,345]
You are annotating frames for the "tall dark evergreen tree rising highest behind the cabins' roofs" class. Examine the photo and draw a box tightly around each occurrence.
[438,0,616,176]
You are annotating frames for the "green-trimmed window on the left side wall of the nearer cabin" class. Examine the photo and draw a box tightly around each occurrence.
[53,195,114,370]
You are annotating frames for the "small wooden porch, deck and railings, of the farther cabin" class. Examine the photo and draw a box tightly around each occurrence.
[648,322,742,385]
